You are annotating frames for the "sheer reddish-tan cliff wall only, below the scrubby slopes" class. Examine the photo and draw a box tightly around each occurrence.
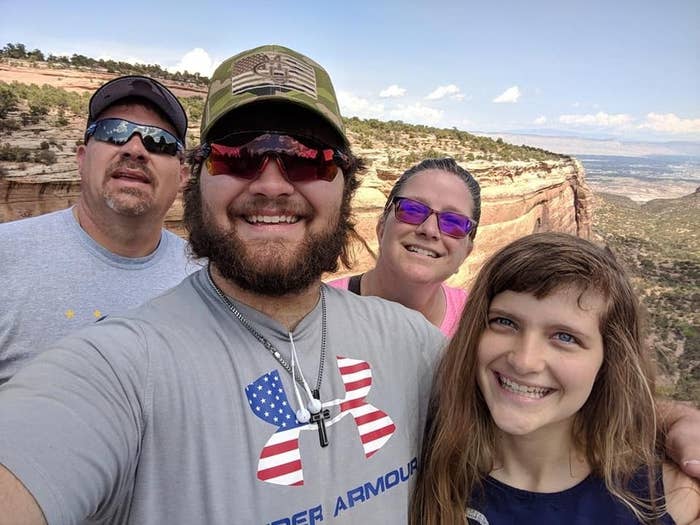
[0,149,592,286]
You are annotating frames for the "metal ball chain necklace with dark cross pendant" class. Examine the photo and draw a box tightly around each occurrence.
[207,265,330,447]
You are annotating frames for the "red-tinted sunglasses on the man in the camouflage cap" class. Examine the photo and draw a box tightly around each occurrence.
[202,133,350,182]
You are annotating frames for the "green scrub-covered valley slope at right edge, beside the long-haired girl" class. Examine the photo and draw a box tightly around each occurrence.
[594,192,700,406]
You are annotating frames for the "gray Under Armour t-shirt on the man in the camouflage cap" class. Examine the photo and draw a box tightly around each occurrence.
[0,270,443,525]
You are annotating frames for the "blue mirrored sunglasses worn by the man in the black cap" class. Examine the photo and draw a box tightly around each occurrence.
[88,118,181,155]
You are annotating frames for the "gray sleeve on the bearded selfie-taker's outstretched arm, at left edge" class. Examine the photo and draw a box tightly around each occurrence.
[0,321,150,524]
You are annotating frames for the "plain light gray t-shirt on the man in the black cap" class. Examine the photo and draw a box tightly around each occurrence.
[0,208,198,384]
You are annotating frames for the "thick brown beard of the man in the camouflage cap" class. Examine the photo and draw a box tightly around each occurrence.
[186,196,349,297]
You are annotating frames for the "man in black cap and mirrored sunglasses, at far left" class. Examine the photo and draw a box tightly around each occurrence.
[0,76,194,384]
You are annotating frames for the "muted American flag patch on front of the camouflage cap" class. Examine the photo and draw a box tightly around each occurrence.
[231,53,318,99]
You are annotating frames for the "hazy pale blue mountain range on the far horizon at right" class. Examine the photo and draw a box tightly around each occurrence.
[475,130,700,157]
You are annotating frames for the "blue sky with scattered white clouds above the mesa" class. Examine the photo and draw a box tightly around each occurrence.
[0,0,700,141]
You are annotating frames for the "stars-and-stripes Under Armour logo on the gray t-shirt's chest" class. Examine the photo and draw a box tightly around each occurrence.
[245,356,396,486]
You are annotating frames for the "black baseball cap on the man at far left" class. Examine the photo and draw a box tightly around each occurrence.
[87,75,187,144]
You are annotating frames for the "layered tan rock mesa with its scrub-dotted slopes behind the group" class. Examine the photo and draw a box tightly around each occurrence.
[0,64,592,286]
